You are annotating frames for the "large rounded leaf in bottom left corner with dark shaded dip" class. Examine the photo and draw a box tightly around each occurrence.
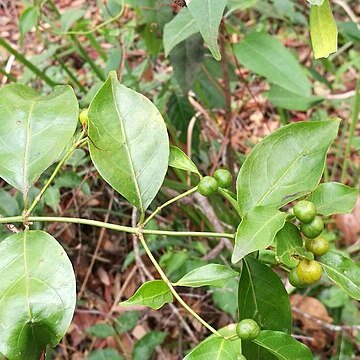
[0,230,76,360]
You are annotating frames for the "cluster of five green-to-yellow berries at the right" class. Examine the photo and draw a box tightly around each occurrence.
[289,200,329,287]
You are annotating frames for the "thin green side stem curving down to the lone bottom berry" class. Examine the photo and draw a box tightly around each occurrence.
[137,233,223,337]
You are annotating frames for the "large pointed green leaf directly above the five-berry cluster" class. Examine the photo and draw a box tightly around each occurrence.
[236,119,339,214]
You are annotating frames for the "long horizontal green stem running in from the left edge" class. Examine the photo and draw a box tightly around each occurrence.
[0,216,235,239]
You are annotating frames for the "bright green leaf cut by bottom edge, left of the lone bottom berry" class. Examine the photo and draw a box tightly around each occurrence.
[184,324,241,360]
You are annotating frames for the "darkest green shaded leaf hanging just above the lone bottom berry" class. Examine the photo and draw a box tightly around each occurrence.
[238,256,291,334]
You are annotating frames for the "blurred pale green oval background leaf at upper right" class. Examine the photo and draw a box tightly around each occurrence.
[234,33,311,96]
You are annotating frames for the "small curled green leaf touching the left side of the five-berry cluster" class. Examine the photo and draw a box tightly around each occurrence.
[275,222,304,269]
